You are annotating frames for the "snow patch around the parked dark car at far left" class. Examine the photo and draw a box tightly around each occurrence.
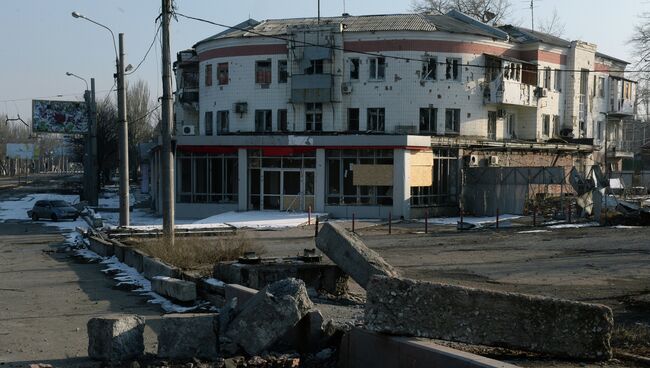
[0,193,86,230]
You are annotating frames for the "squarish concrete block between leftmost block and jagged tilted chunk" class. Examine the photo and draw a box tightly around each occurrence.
[158,314,219,360]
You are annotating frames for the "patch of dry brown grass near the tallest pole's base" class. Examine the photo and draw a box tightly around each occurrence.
[126,234,264,273]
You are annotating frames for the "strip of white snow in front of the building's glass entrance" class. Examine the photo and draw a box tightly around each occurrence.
[194,211,325,229]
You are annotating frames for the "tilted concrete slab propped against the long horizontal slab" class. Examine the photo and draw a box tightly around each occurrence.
[316,222,398,288]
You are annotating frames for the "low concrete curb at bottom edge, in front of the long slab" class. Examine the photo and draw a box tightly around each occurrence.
[339,328,517,368]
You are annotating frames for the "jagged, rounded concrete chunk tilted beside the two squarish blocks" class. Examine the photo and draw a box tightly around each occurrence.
[225,278,313,355]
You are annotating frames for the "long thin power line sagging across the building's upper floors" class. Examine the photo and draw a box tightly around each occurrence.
[174,12,647,73]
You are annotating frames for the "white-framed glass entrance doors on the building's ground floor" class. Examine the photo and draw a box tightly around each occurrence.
[260,169,316,211]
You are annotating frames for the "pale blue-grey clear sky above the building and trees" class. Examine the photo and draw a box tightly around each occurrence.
[0,0,650,120]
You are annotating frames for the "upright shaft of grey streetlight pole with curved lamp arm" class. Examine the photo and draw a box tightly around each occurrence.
[117,33,129,226]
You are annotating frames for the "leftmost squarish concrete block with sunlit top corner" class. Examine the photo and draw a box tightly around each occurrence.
[87,315,144,362]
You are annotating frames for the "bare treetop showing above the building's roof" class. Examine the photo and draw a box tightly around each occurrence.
[411,0,512,24]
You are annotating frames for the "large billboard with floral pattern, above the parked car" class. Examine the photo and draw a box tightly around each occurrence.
[32,100,88,134]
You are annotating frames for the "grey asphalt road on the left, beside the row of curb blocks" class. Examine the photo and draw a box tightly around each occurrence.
[0,178,161,367]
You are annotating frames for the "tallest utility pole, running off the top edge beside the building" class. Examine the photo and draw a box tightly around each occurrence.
[160,0,175,246]
